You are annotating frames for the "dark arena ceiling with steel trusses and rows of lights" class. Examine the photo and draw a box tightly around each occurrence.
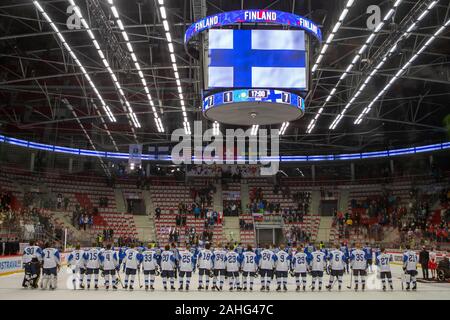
[0,0,450,154]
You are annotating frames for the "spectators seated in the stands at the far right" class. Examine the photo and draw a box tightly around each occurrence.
[334,188,450,245]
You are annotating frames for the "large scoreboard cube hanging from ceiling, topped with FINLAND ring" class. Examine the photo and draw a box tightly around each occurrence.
[184,10,322,126]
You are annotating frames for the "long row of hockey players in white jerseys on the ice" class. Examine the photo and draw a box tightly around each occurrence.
[23,242,418,291]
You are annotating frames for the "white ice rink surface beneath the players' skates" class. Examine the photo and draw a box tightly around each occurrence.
[0,266,450,300]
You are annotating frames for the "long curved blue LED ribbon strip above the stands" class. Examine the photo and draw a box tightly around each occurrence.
[0,135,450,162]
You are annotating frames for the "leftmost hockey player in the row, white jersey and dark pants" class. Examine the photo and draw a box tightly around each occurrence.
[22,241,42,289]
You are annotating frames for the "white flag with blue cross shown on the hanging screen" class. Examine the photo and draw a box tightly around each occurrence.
[208,29,306,89]
